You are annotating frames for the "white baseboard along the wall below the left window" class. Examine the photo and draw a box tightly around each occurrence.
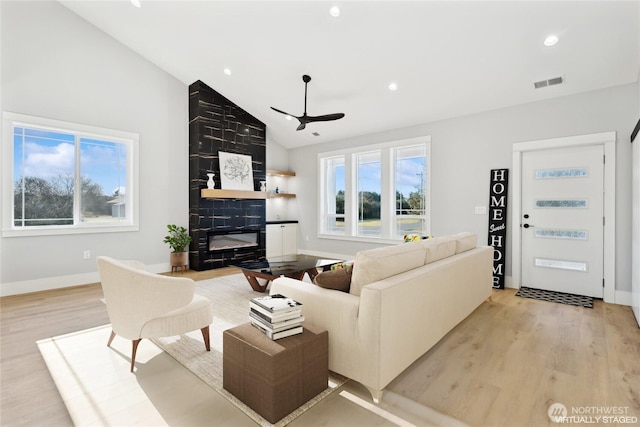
[0,263,171,297]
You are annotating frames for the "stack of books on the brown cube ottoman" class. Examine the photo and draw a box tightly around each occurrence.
[249,294,304,340]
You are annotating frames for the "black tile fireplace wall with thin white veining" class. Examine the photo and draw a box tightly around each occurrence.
[189,80,266,271]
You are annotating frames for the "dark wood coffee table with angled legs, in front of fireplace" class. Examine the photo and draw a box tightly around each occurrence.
[234,255,342,292]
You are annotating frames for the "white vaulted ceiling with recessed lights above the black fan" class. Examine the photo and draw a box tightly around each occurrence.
[60,0,640,148]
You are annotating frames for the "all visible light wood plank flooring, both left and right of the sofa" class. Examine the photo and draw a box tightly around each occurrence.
[0,268,640,426]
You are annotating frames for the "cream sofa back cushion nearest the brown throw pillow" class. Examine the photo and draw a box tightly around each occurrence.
[349,242,426,295]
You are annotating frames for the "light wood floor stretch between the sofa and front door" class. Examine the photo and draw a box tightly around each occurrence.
[388,289,640,426]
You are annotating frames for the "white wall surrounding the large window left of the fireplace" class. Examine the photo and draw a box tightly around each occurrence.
[0,2,188,295]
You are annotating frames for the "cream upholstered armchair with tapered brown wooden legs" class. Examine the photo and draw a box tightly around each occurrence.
[97,256,213,372]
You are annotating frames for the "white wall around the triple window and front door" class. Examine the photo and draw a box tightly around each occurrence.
[289,84,640,292]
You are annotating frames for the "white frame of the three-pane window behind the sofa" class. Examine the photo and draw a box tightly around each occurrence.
[318,136,431,244]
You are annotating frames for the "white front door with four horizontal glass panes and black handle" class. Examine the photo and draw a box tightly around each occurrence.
[519,145,604,298]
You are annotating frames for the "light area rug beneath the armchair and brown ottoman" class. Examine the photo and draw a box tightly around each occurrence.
[37,274,346,427]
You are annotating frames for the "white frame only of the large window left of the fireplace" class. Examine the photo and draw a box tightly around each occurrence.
[0,112,139,237]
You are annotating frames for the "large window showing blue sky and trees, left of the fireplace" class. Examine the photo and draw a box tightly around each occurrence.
[3,114,137,237]
